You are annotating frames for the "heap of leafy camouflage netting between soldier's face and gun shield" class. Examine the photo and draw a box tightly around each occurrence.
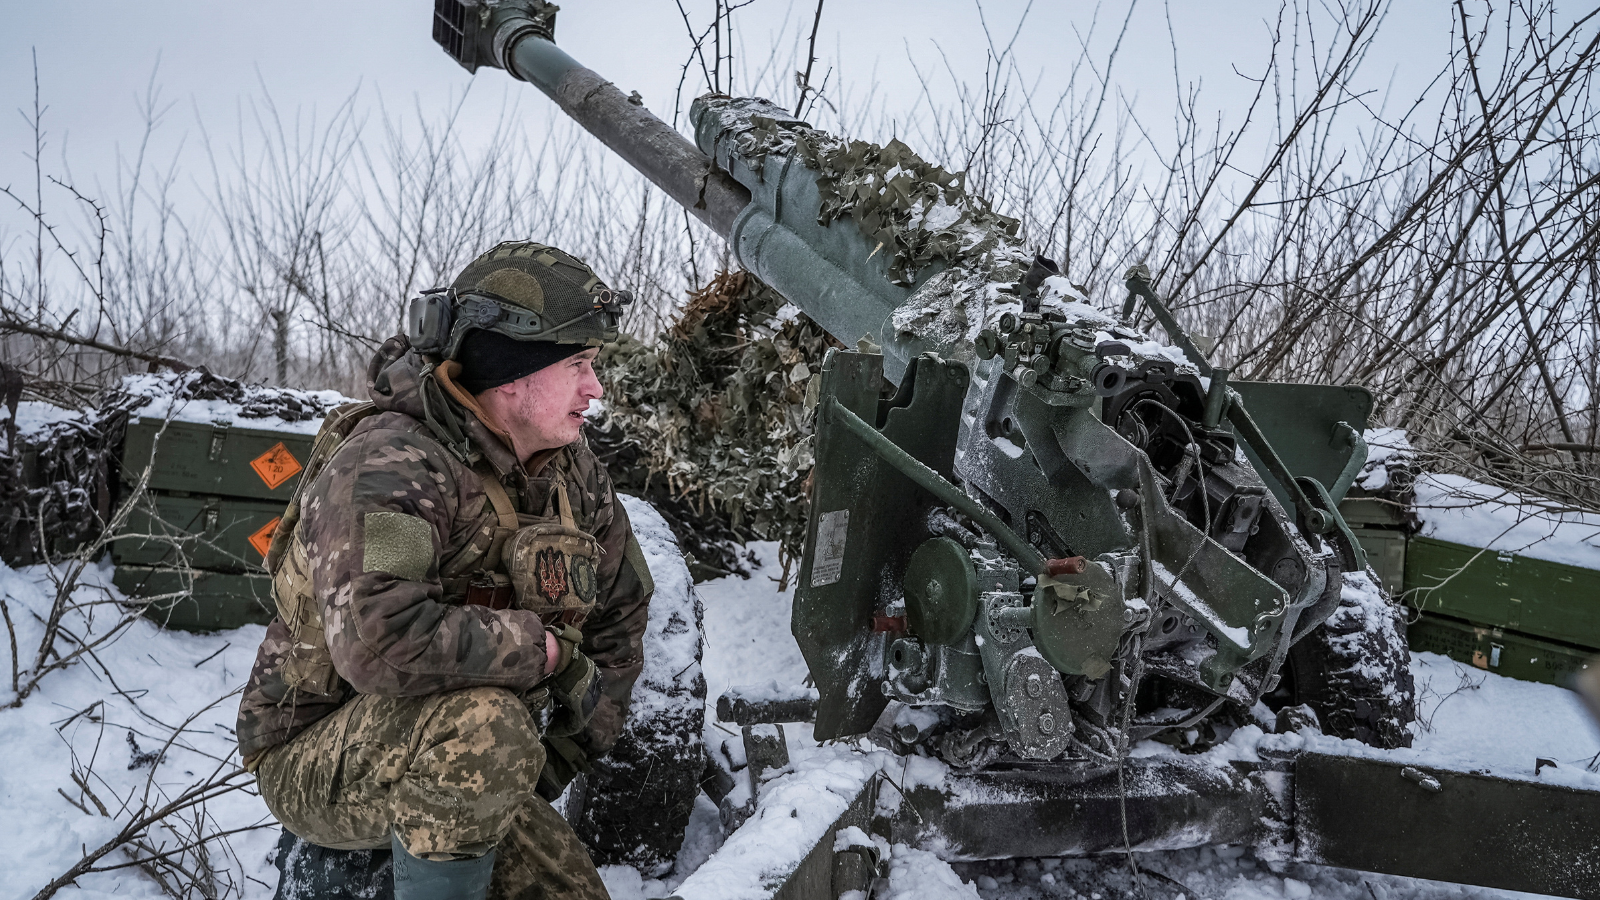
[589,272,838,580]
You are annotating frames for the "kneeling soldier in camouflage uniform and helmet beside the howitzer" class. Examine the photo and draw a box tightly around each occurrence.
[238,243,653,900]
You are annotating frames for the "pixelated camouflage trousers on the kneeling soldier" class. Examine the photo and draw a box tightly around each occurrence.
[256,687,608,900]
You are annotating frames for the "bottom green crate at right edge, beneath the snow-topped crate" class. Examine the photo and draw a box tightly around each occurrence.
[1406,613,1594,685]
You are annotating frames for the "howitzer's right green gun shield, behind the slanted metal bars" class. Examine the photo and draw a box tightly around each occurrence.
[1229,381,1373,509]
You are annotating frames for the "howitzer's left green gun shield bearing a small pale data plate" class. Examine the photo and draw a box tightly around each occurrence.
[794,351,968,740]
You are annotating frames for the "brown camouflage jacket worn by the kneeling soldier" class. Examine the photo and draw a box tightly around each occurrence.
[238,338,651,765]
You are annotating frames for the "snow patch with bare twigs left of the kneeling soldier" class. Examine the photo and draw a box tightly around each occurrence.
[0,564,277,900]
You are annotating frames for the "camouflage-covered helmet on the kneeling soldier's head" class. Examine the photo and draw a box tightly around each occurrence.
[406,242,634,359]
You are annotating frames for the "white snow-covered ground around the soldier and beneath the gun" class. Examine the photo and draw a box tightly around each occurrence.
[0,534,1600,900]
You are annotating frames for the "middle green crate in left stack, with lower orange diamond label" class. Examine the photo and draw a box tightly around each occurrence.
[112,493,283,572]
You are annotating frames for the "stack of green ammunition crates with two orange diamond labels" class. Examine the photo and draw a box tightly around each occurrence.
[112,418,314,631]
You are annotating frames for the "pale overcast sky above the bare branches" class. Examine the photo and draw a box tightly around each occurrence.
[0,0,1450,237]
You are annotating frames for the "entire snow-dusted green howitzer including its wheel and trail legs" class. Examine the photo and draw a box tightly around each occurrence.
[434,0,1600,895]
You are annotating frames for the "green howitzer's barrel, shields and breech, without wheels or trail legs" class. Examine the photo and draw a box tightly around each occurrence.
[435,3,1371,761]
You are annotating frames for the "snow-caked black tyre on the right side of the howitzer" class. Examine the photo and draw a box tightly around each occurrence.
[1283,570,1416,749]
